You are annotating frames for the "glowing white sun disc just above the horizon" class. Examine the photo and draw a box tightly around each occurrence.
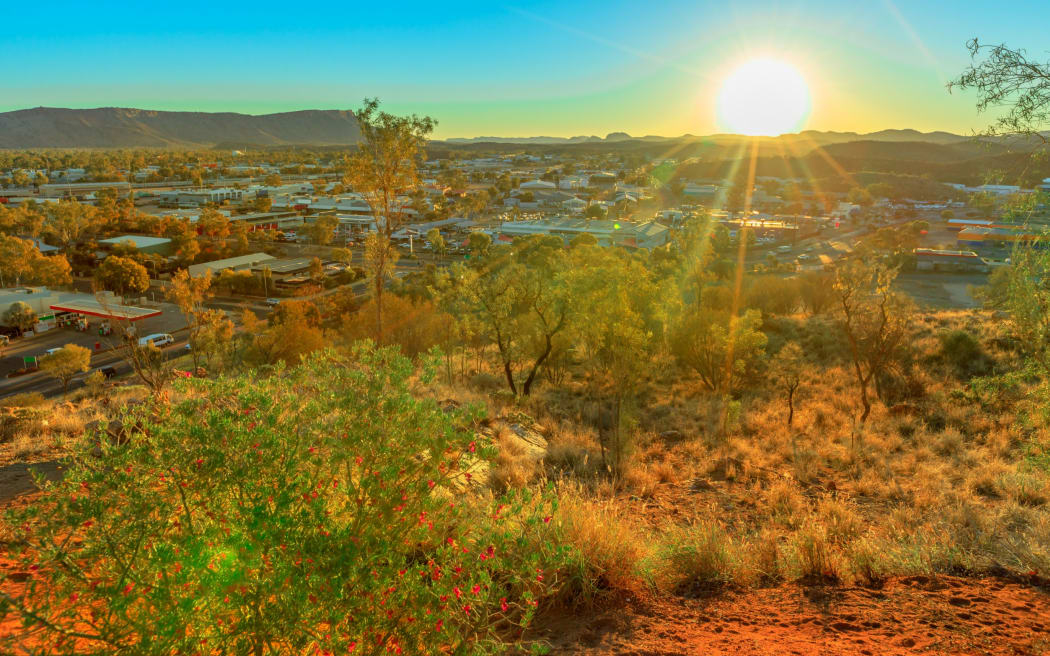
[718,58,810,136]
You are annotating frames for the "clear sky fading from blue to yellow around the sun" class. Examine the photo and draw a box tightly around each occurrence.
[0,0,1050,137]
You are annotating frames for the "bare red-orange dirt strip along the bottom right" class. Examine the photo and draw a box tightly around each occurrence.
[539,577,1050,656]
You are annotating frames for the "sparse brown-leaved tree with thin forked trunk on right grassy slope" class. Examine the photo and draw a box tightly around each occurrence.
[834,258,911,424]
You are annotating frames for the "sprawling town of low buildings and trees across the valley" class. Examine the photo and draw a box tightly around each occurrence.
[0,142,1050,396]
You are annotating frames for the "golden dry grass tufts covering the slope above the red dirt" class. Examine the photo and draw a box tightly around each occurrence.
[506,313,1050,588]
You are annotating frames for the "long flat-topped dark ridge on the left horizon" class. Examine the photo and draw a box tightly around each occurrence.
[0,107,360,148]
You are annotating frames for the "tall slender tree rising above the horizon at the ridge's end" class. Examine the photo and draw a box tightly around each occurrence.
[345,99,436,336]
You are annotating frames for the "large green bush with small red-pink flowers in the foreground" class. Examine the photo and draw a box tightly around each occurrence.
[5,345,569,655]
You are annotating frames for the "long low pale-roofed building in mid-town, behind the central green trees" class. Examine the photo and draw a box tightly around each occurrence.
[497,218,670,249]
